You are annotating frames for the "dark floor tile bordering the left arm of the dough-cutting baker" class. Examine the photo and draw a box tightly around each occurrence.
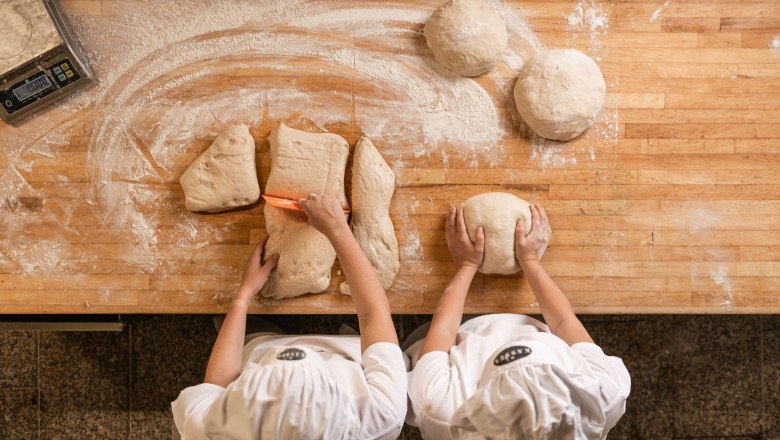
[130,315,217,411]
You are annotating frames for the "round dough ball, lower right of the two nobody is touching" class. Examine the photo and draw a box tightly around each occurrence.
[515,49,607,141]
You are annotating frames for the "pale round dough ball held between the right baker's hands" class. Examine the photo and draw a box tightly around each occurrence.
[460,193,531,275]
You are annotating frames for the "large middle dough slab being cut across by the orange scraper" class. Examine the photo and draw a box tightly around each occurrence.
[261,124,349,299]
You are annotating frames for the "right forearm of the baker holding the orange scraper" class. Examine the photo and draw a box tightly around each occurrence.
[329,224,398,350]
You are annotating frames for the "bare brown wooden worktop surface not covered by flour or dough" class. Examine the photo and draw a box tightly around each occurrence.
[0,0,780,313]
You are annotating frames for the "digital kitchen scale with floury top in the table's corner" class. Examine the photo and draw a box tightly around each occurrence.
[0,0,93,123]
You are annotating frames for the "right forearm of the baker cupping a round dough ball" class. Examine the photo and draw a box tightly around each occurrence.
[521,260,593,345]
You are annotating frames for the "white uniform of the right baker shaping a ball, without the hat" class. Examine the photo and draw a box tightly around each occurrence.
[406,314,631,440]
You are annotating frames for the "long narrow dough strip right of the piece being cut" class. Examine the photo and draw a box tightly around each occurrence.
[339,137,399,295]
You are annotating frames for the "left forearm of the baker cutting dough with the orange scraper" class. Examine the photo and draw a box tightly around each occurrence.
[204,289,254,387]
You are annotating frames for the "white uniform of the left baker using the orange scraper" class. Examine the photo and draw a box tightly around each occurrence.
[171,335,407,440]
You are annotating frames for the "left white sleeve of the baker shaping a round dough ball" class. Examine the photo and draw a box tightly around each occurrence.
[406,351,462,438]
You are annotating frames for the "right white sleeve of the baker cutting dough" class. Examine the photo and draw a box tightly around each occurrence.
[361,342,407,438]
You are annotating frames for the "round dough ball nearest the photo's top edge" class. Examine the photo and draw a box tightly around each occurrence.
[425,0,507,76]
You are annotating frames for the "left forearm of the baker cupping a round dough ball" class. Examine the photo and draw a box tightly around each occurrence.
[419,266,477,357]
